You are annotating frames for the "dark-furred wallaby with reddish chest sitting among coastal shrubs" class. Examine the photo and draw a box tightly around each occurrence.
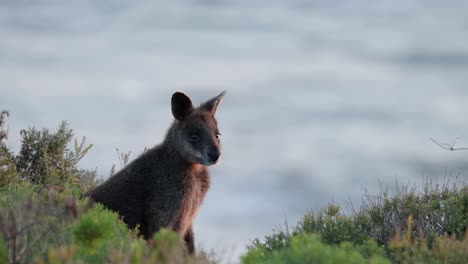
[88,91,226,254]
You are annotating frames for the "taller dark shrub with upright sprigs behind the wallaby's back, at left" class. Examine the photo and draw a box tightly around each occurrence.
[0,111,96,190]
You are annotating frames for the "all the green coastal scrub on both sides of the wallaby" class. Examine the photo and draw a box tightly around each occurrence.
[0,111,468,264]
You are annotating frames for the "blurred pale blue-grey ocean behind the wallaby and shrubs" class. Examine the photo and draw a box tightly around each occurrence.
[0,0,468,262]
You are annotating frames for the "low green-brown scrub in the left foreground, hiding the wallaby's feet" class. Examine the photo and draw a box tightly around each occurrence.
[0,183,210,263]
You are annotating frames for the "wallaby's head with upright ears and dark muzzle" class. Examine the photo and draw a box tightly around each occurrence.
[166,91,226,166]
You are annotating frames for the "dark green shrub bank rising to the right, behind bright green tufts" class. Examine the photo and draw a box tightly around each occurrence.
[248,180,468,263]
